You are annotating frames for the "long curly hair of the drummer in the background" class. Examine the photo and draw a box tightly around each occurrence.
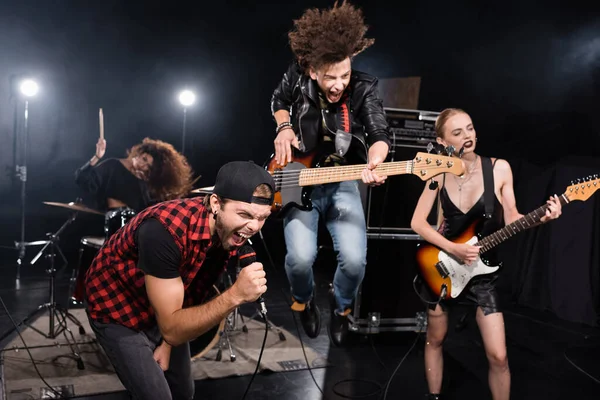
[127,138,195,201]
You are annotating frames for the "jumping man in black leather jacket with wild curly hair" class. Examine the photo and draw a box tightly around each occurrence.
[271,2,390,345]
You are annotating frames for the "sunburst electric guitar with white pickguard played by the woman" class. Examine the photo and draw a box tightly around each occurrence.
[416,174,600,299]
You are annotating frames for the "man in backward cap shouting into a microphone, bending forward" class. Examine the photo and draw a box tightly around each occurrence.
[86,162,275,399]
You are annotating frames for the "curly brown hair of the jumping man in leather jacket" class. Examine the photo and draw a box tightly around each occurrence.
[288,1,375,73]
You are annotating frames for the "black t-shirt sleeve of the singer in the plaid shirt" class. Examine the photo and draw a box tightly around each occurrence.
[135,218,181,279]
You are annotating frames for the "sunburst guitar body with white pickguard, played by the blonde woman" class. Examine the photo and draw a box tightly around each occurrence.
[416,220,500,299]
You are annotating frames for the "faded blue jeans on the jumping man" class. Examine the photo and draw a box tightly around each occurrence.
[283,181,367,313]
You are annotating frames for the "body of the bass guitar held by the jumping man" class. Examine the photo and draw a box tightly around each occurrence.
[265,144,344,218]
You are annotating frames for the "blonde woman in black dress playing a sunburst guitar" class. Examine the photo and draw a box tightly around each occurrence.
[411,108,561,399]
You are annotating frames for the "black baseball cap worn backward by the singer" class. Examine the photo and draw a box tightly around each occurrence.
[213,161,275,206]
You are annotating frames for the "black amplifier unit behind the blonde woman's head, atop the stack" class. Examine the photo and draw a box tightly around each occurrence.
[384,107,440,142]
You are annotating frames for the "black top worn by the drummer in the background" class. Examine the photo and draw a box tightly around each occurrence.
[75,158,154,212]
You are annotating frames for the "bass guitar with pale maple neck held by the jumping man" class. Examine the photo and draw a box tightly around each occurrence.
[265,146,465,217]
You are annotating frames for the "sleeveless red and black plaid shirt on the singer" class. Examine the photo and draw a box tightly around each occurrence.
[85,198,229,330]
